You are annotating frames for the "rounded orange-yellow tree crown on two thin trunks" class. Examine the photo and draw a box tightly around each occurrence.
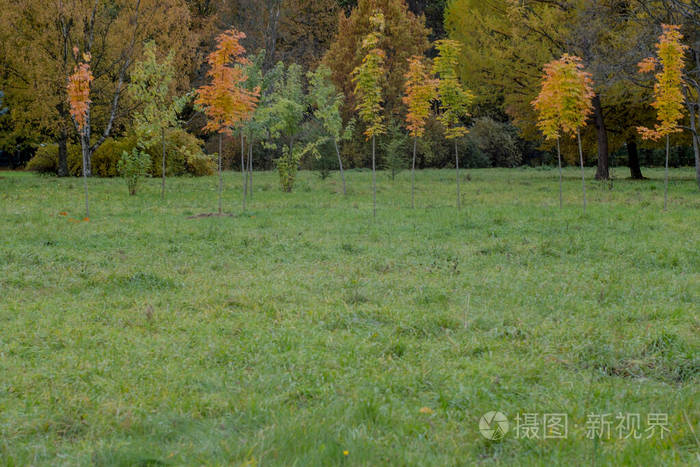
[532,54,595,213]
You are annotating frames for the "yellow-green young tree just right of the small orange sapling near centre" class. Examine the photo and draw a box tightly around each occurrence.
[433,39,474,209]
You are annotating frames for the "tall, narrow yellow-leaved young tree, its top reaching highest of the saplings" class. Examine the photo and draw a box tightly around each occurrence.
[352,11,386,217]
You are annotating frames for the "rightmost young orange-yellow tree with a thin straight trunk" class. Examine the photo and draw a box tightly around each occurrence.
[637,24,688,211]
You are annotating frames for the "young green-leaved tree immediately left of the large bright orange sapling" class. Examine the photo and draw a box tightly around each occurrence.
[129,42,189,199]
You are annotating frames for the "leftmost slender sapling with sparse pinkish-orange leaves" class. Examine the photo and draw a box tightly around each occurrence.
[66,47,93,219]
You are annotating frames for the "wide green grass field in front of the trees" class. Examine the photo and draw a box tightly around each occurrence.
[0,168,700,466]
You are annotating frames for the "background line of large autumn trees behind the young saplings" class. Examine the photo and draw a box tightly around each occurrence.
[0,0,700,192]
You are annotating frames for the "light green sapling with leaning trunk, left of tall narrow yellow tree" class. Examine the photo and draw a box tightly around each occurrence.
[307,64,354,195]
